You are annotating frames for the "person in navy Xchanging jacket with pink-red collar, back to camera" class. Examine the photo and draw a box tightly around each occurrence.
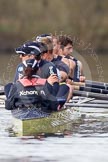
[5,59,69,117]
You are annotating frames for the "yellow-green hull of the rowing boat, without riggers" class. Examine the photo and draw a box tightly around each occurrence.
[13,108,81,136]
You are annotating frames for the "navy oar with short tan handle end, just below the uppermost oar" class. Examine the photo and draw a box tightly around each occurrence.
[74,86,108,94]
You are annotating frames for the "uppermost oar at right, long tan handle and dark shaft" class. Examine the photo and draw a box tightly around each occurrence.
[72,80,108,90]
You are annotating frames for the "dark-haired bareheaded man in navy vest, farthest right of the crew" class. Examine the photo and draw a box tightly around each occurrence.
[53,36,85,82]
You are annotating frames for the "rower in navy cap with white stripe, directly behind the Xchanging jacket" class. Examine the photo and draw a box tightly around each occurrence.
[14,41,57,82]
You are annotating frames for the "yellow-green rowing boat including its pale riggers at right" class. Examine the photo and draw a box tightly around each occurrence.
[13,98,108,136]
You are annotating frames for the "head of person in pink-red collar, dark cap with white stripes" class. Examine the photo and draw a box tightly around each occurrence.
[23,59,39,79]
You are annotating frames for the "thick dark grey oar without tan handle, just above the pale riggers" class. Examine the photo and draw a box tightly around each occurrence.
[73,90,108,100]
